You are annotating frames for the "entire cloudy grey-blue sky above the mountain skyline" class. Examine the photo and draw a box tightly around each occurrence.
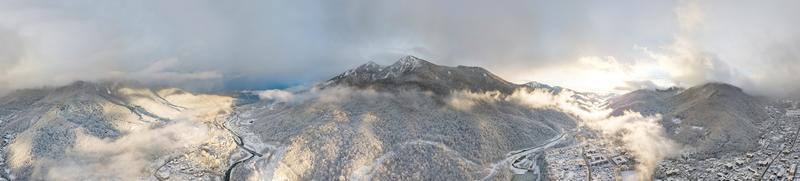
[0,0,800,96]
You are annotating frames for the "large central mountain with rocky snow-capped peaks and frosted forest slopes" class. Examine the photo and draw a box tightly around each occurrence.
[236,57,576,180]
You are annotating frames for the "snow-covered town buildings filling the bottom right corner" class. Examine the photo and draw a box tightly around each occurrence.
[654,104,800,180]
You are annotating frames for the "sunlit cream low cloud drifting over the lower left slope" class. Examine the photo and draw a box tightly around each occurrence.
[43,121,210,180]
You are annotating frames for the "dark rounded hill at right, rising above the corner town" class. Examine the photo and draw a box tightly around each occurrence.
[609,83,767,156]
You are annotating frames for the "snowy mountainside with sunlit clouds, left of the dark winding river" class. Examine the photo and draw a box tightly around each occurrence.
[0,82,235,180]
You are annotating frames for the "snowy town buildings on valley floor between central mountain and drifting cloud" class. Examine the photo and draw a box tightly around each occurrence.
[544,139,635,180]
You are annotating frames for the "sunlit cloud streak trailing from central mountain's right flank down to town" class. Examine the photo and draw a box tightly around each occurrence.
[448,88,681,178]
